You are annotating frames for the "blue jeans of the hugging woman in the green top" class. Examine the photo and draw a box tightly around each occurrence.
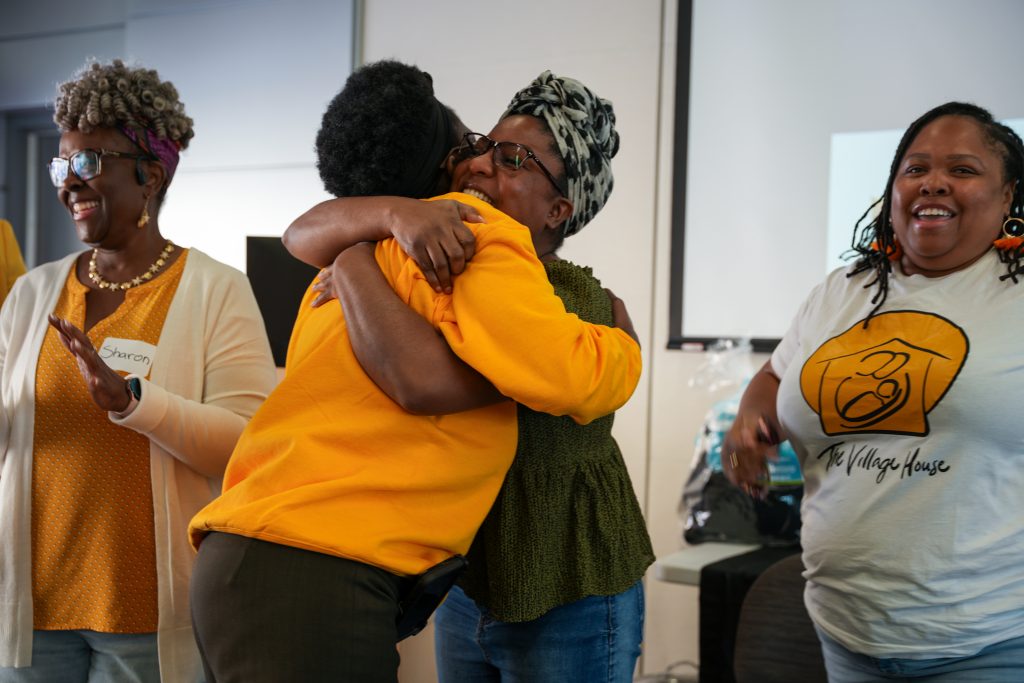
[434,582,644,683]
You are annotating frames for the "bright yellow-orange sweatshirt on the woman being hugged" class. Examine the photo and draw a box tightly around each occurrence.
[190,195,641,574]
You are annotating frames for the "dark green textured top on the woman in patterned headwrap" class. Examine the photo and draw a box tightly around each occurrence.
[459,261,654,622]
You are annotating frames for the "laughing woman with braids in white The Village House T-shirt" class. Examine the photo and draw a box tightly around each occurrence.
[722,102,1024,683]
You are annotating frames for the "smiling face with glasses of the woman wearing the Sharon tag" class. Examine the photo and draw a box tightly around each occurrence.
[57,128,160,249]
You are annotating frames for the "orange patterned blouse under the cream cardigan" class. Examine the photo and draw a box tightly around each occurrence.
[32,252,187,633]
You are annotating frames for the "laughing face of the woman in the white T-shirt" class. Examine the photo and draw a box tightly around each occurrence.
[892,116,1013,278]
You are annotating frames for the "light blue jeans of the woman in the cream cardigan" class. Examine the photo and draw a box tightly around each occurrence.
[0,631,160,683]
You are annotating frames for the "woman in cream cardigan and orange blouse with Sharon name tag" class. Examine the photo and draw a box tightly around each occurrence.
[0,59,274,683]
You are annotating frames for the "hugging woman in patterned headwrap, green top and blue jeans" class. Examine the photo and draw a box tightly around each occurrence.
[286,72,653,683]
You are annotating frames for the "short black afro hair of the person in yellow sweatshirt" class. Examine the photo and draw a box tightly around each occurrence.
[316,59,457,197]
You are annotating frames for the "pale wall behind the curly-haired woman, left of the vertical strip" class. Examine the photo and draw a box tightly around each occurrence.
[0,0,353,269]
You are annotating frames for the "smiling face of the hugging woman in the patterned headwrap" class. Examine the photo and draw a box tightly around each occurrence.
[452,116,572,256]
